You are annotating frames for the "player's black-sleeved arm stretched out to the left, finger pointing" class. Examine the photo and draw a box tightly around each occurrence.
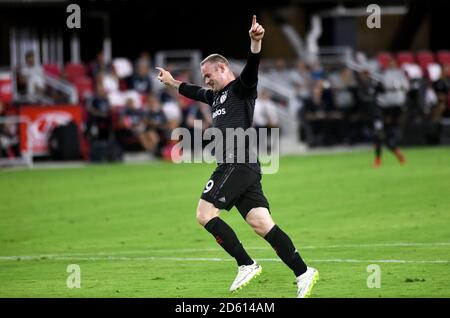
[156,67,214,105]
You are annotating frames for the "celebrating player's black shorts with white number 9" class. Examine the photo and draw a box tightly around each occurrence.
[201,164,270,219]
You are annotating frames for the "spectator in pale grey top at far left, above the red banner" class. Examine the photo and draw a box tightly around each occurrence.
[18,51,45,102]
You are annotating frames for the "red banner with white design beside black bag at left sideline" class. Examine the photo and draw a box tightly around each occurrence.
[20,105,82,155]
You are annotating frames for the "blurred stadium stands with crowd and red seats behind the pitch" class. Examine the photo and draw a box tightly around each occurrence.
[0,0,450,164]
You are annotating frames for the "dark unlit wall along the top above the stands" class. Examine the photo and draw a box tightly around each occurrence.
[0,0,450,65]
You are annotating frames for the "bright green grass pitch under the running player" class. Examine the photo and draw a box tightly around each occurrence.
[0,148,450,298]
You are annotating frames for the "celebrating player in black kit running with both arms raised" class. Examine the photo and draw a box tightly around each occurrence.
[157,16,319,298]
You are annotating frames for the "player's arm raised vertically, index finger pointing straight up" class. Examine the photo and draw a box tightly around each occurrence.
[240,15,265,87]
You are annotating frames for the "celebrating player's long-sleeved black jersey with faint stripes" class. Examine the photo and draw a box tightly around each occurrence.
[179,52,261,172]
